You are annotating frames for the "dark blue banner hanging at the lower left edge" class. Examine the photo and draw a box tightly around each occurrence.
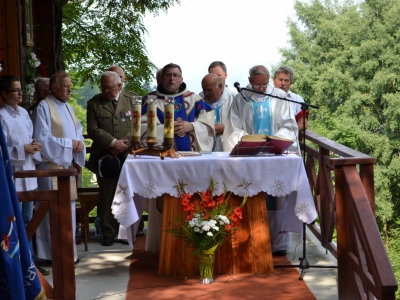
[0,128,44,299]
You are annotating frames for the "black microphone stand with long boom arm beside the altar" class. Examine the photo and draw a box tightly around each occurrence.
[240,88,337,280]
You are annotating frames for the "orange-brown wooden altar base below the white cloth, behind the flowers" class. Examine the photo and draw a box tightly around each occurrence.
[158,193,274,277]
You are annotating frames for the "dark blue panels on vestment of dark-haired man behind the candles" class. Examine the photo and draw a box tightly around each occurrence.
[142,93,212,151]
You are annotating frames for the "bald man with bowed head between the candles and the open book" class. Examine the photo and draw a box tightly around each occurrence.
[200,73,234,152]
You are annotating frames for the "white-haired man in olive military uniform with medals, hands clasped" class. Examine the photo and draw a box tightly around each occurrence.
[87,67,134,246]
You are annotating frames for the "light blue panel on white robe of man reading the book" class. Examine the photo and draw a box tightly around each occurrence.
[250,97,274,135]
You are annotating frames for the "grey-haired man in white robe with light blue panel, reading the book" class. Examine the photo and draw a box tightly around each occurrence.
[222,65,300,255]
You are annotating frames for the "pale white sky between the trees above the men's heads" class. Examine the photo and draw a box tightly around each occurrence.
[144,0,295,93]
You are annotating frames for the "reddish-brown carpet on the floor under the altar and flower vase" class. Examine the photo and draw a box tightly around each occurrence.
[126,237,316,300]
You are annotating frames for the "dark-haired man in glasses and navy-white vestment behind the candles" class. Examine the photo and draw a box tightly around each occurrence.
[142,63,214,151]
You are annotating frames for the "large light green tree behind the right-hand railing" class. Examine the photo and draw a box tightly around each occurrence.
[280,0,400,290]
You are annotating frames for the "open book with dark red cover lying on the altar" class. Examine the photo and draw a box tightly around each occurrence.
[229,134,294,156]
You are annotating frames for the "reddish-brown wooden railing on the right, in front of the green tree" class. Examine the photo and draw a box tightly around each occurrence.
[305,131,398,300]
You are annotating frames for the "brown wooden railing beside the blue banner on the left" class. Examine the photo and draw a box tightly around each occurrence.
[14,169,76,300]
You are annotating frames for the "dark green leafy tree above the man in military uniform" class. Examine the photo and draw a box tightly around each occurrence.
[61,0,179,93]
